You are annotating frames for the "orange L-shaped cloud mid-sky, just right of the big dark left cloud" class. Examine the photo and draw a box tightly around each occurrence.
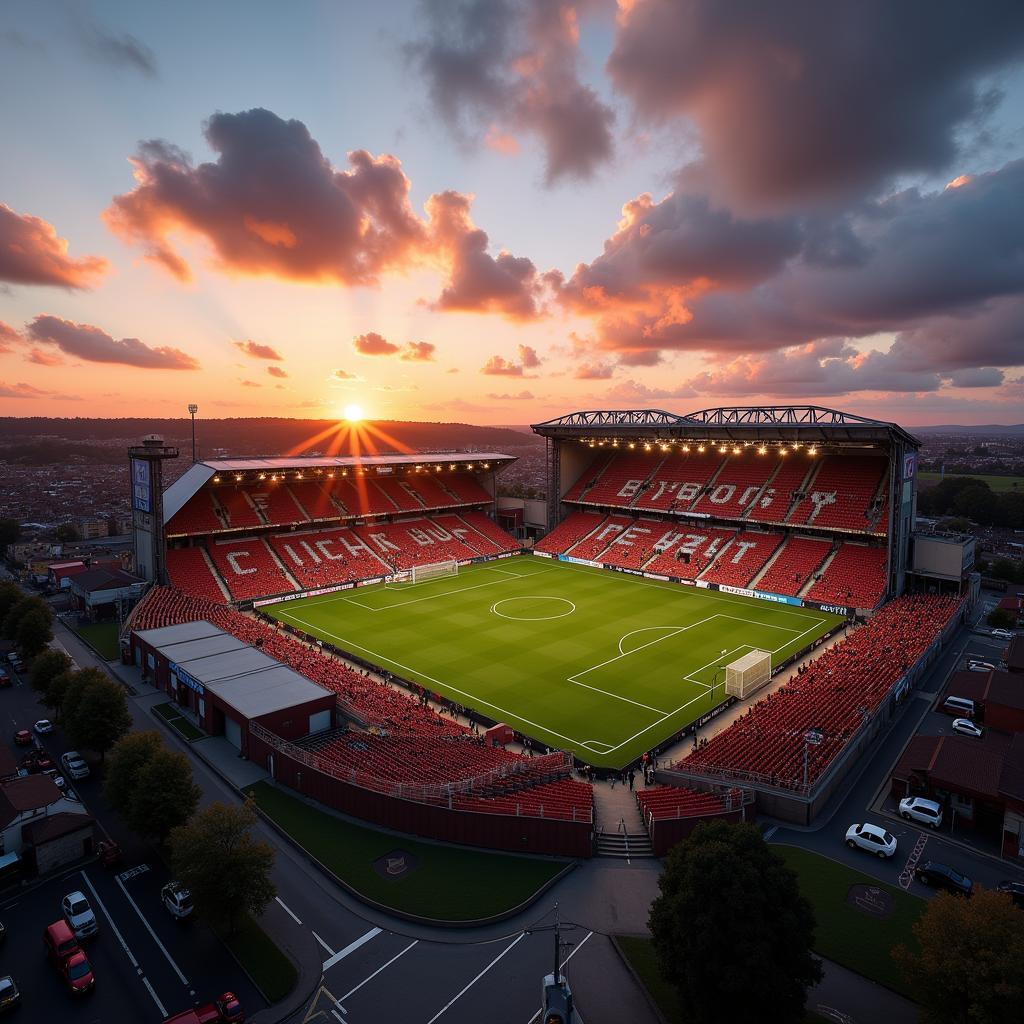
[427,191,546,319]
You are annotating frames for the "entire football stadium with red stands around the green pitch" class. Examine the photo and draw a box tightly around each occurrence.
[122,407,976,857]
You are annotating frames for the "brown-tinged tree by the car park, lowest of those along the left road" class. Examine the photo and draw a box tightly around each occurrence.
[170,803,276,933]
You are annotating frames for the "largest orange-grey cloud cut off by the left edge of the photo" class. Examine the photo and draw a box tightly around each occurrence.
[0,203,109,288]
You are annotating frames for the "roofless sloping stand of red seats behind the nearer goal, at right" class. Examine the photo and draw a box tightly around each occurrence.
[675,595,961,788]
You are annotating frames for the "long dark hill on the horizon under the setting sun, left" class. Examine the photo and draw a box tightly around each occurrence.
[0,417,544,462]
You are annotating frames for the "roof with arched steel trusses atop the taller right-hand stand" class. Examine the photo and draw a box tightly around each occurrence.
[532,406,921,447]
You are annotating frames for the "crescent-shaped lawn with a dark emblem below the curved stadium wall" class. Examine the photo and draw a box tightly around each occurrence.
[245,782,567,924]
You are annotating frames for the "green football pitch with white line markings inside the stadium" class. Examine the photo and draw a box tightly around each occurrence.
[263,555,842,768]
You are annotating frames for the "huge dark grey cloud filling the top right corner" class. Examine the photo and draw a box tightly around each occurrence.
[607,0,1024,204]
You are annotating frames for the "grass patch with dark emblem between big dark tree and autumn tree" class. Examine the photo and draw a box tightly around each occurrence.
[773,845,925,999]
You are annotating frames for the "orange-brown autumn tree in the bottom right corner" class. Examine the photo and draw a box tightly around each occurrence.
[893,889,1024,1024]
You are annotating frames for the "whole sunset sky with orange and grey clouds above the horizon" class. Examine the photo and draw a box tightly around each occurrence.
[0,0,1024,426]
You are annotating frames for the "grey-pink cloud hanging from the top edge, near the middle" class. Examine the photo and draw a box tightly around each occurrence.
[407,0,614,183]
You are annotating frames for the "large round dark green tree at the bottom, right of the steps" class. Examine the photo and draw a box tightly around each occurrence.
[649,821,821,1024]
